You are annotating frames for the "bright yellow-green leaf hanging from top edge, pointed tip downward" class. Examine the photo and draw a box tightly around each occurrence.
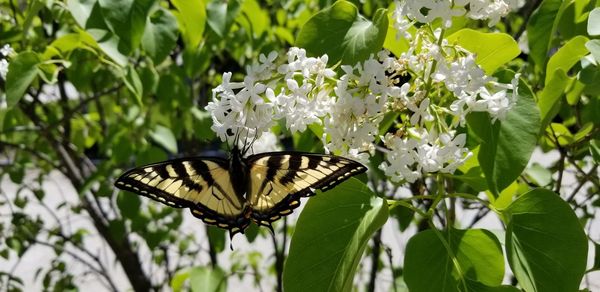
[172,0,206,50]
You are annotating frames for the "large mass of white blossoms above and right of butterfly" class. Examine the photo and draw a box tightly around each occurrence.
[206,40,518,182]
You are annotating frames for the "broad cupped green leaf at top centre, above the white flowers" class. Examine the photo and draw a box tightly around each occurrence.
[296,1,388,64]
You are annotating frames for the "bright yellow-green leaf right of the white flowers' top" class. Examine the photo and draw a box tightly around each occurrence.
[448,28,521,75]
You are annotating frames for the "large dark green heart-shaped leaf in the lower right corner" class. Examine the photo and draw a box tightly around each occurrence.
[502,189,588,292]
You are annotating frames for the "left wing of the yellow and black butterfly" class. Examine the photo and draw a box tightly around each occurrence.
[115,157,249,236]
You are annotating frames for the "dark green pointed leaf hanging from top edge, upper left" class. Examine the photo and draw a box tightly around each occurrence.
[98,0,155,54]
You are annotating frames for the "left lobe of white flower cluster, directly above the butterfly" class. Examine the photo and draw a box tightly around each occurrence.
[206,48,335,146]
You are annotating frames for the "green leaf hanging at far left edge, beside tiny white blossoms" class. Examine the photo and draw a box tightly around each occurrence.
[6,51,40,109]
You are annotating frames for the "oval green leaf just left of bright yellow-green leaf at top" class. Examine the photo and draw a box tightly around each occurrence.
[142,8,177,64]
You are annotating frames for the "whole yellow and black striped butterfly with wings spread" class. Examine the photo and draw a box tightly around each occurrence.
[115,147,367,238]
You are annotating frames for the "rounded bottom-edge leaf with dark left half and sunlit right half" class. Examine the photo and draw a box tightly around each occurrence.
[404,229,504,292]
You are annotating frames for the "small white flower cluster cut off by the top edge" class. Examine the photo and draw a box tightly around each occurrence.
[393,0,524,38]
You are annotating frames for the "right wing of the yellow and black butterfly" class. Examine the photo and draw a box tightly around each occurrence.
[247,152,366,227]
